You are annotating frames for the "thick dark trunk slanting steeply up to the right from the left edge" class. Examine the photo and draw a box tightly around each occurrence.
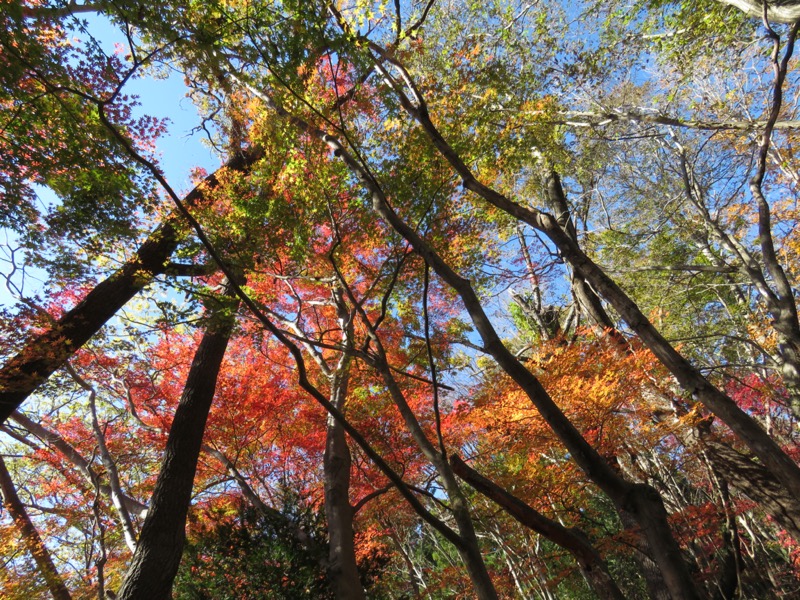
[0,148,264,424]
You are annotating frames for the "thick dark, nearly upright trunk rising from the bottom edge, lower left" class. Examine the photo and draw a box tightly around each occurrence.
[117,286,235,600]
